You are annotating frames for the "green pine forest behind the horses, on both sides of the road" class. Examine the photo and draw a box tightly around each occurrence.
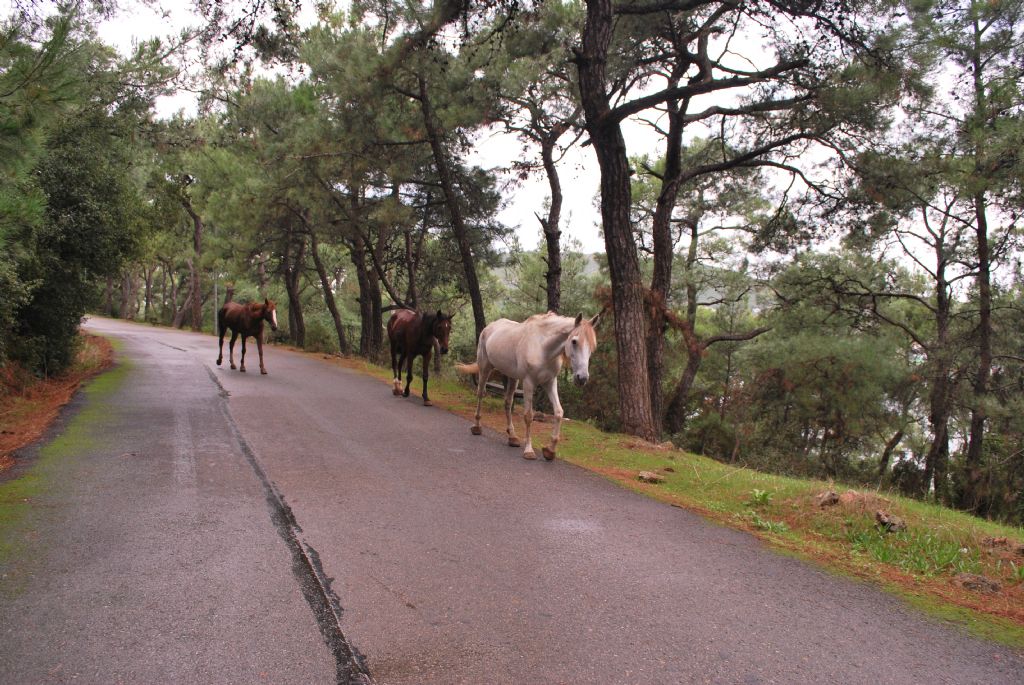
[0,0,1024,524]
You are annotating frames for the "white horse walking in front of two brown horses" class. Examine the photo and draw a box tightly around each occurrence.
[456,311,601,461]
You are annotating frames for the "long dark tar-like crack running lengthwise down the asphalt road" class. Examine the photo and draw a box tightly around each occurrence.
[204,365,374,685]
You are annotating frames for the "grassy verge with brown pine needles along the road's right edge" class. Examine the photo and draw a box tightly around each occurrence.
[329,356,1024,648]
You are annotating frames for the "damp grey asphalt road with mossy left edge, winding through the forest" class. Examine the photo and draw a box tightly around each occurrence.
[0,318,1024,685]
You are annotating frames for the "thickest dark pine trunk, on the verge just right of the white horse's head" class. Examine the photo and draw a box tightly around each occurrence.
[577,0,658,440]
